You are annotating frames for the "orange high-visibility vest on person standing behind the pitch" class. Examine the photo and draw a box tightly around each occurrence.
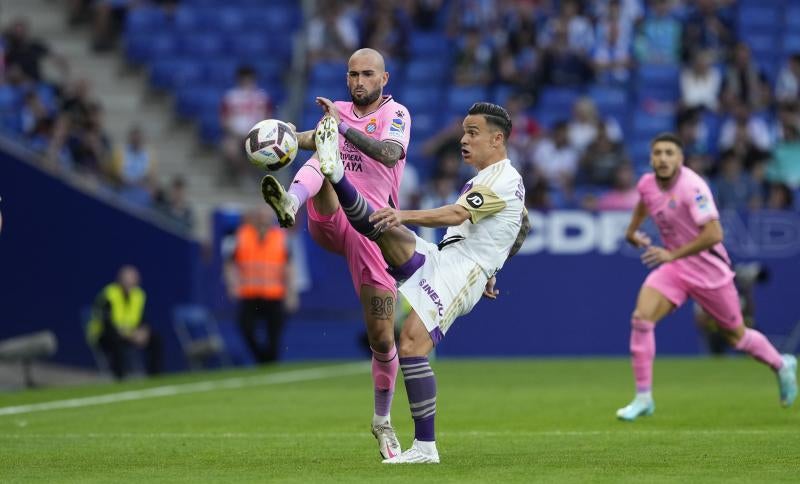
[235,224,289,299]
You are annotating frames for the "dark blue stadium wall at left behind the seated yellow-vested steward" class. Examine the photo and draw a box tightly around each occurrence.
[0,150,199,370]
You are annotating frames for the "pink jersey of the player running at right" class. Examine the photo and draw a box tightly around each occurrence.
[637,167,733,288]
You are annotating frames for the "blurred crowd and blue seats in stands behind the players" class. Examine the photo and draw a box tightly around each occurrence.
[0,0,800,234]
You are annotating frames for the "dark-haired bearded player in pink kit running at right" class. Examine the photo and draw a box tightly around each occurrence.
[617,133,797,421]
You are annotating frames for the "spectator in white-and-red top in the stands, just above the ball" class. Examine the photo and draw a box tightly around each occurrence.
[220,66,272,183]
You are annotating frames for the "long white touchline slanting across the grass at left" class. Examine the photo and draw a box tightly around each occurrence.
[0,363,369,416]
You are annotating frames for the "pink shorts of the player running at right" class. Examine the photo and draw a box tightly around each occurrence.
[644,264,742,329]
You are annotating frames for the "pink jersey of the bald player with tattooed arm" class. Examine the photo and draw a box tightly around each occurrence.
[335,96,411,209]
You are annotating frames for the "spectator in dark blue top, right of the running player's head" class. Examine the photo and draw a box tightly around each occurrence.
[713,151,764,210]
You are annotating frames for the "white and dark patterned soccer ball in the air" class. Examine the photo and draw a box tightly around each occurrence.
[244,119,297,171]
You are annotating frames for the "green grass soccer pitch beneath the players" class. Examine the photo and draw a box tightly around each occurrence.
[0,358,800,483]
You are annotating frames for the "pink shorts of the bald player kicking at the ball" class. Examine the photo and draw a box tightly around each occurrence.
[306,200,397,298]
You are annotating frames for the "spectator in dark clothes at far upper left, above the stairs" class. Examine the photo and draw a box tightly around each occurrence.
[4,18,69,82]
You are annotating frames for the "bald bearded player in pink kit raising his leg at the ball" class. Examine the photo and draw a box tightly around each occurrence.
[261,49,411,459]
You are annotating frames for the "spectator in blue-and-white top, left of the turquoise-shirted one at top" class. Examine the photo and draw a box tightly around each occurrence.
[592,0,633,84]
